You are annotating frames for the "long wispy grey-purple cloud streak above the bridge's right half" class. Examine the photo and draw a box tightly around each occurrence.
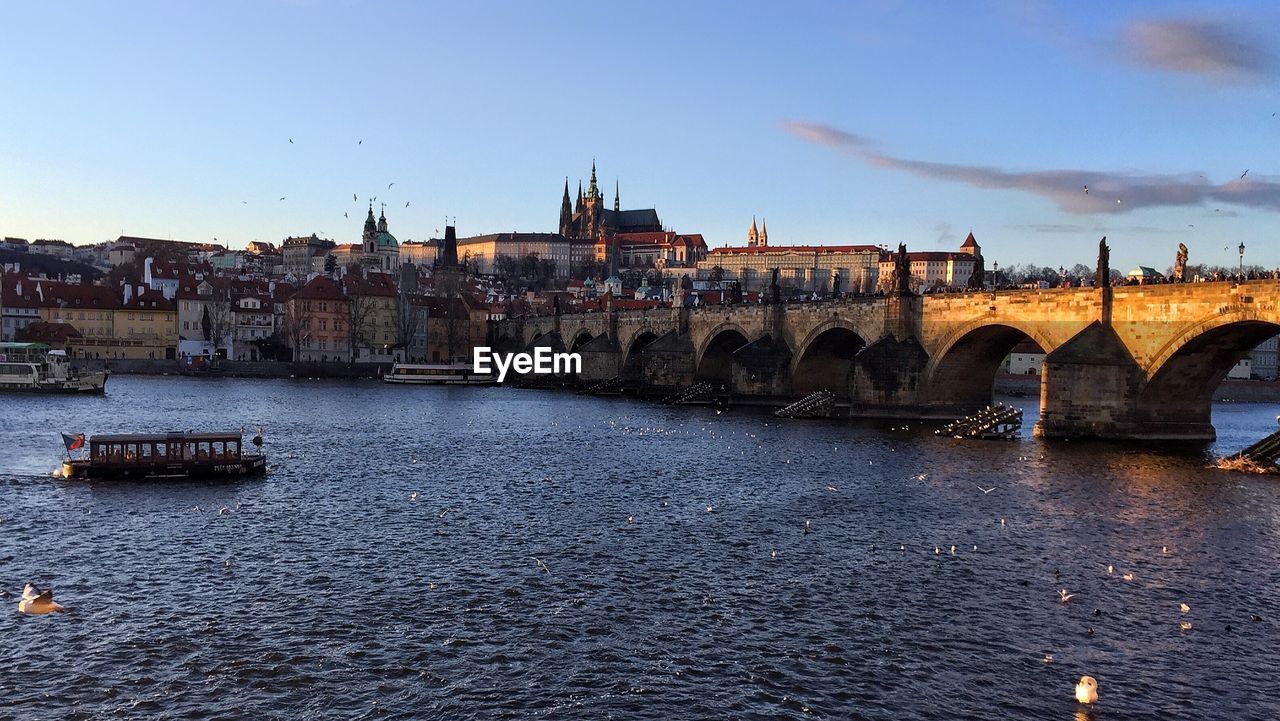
[782,120,1280,215]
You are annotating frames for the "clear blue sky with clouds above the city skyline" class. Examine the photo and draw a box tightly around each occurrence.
[0,0,1280,274]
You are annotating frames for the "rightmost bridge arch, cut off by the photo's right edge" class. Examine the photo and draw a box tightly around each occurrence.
[1137,310,1280,428]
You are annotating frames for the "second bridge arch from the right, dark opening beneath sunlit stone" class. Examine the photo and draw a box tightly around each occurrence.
[924,319,1056,409]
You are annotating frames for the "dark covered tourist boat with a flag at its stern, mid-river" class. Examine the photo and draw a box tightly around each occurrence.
[63,430,266,479]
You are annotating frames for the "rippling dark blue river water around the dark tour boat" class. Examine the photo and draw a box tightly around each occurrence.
[0,377,1280,721]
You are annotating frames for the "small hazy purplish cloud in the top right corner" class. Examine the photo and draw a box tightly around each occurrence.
[1120,19,1275,83]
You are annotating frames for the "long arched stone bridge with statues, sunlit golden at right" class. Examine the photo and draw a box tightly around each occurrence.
[494,280,1280,439]
